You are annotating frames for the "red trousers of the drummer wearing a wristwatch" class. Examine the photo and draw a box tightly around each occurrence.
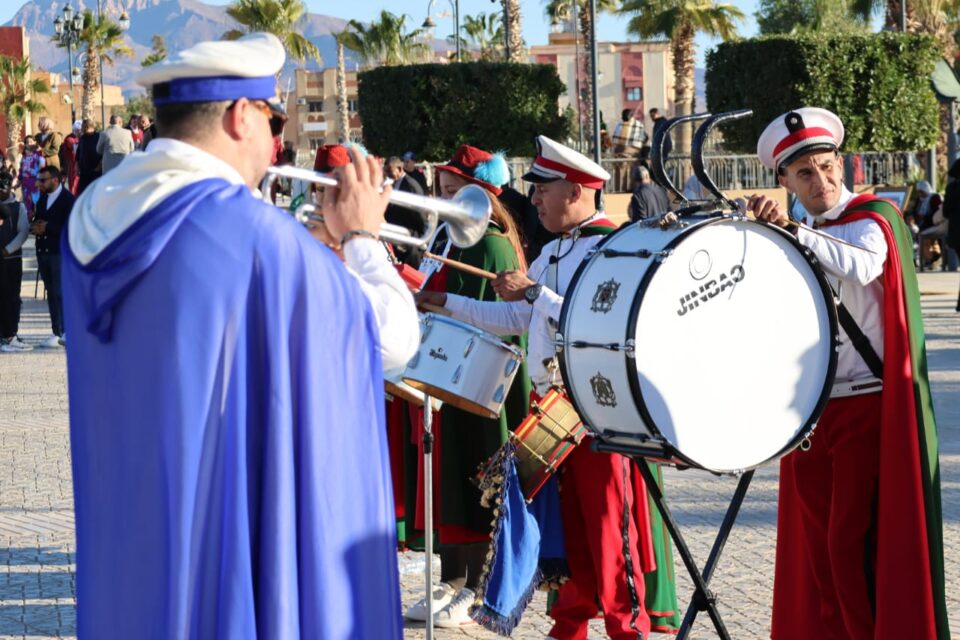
[550,438,650,640]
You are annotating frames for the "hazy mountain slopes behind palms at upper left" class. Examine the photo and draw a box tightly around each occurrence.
[6,0,376,93]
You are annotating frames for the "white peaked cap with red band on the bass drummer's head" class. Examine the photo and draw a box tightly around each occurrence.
[757,107,843,171]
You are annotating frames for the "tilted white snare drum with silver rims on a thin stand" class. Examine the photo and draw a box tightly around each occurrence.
[403,313,523,418]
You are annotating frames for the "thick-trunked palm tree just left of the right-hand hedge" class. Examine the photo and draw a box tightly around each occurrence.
[620,0,744,153]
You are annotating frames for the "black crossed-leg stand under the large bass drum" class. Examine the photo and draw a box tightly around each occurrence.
[592,439,753,640]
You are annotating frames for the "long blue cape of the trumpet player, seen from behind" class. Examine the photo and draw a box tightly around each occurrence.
[63,179,402,639]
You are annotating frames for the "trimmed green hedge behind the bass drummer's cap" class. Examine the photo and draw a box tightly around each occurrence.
[706,33,940,153]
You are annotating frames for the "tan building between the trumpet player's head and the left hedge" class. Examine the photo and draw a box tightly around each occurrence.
[284,69,362,151]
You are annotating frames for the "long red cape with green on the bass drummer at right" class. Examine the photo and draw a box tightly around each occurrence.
[771,195,950,640]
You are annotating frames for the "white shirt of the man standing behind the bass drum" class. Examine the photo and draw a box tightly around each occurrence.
[797,187,887,382]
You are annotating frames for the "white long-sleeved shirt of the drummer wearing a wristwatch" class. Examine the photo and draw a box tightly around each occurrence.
[444,214,604,394]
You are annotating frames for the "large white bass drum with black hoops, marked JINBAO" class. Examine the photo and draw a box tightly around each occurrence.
[557,216,837,473]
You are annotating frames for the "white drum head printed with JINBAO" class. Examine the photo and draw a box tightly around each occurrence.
[634,222,834,472]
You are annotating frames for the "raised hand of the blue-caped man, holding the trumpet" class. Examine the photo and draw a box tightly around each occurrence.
[323,147,391,243]
